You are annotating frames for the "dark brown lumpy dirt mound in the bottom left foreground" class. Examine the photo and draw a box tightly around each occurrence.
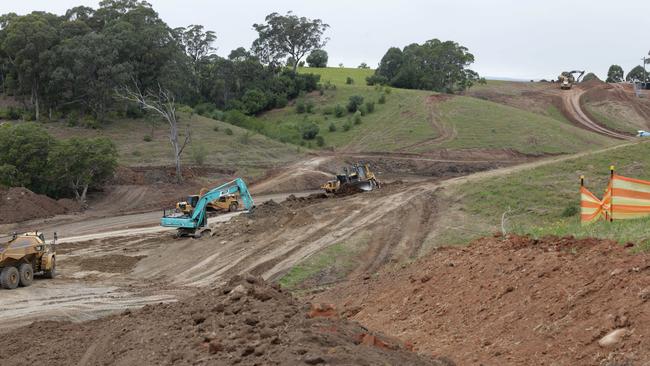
[0,275,453,365]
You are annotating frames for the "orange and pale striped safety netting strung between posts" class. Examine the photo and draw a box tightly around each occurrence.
[580,174,650,224]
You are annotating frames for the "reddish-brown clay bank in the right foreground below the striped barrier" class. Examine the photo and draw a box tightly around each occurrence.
[316,236,650,365]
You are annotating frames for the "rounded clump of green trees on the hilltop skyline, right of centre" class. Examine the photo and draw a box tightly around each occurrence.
[367,39,482,93]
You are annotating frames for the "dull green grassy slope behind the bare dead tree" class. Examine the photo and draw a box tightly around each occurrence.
[43,115,300,169]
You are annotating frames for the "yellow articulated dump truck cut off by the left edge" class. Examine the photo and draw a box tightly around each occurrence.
[0,232,56,289]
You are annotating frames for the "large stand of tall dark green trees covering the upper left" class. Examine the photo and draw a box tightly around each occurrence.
[0,0,326,122]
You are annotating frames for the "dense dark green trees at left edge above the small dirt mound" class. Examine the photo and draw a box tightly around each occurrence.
[0,123,117,201]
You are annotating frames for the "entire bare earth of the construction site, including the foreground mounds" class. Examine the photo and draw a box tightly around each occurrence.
[0,81,650,365]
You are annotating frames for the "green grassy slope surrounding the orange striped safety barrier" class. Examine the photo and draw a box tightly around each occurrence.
[441,142,650,250]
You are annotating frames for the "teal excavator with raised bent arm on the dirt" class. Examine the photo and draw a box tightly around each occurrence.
[160,178,254,237]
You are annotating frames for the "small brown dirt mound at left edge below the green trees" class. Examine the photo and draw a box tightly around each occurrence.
[0,187,81,224]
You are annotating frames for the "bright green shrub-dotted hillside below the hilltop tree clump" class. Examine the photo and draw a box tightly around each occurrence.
[259,68,612,155]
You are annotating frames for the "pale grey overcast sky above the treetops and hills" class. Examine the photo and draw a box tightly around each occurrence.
[0,0,650,79]
